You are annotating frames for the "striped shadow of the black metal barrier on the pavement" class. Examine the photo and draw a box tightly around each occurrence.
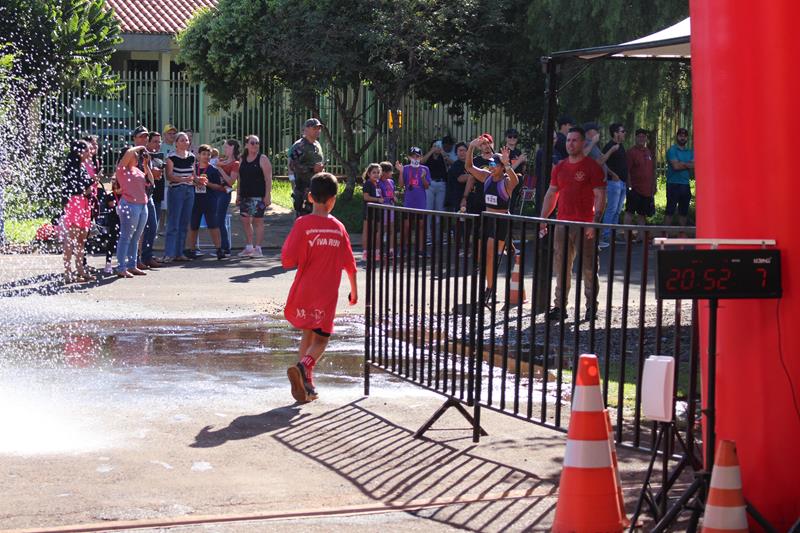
[273,402,557,531]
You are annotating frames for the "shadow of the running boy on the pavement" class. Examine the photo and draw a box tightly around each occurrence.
[189,405,305,448]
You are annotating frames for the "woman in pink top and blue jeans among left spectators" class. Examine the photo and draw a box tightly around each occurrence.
[115,146,148,278]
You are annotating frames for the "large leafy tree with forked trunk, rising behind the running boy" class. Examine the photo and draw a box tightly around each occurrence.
[178,0,528,195]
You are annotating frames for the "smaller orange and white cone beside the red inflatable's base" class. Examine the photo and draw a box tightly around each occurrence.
[702,440,748,533]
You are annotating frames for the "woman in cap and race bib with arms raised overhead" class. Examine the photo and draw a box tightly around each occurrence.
[462,135,519,303]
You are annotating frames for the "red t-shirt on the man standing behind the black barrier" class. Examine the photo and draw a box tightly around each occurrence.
[550,157,606,222]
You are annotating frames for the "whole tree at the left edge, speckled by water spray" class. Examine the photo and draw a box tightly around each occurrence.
[0,0,122,242]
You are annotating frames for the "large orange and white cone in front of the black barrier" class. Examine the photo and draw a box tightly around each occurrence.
[552,354,625,533]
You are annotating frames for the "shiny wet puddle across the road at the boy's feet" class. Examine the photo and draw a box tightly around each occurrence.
[0,318,400,455]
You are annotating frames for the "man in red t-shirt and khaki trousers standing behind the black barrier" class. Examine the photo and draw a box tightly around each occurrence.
[542,127,606,320]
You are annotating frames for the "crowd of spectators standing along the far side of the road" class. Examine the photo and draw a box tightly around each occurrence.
[60,116,694,319]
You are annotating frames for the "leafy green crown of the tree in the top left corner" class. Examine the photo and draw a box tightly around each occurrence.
[0,0,122,98]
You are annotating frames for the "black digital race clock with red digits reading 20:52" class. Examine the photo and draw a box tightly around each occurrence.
[656,249,781,300]
